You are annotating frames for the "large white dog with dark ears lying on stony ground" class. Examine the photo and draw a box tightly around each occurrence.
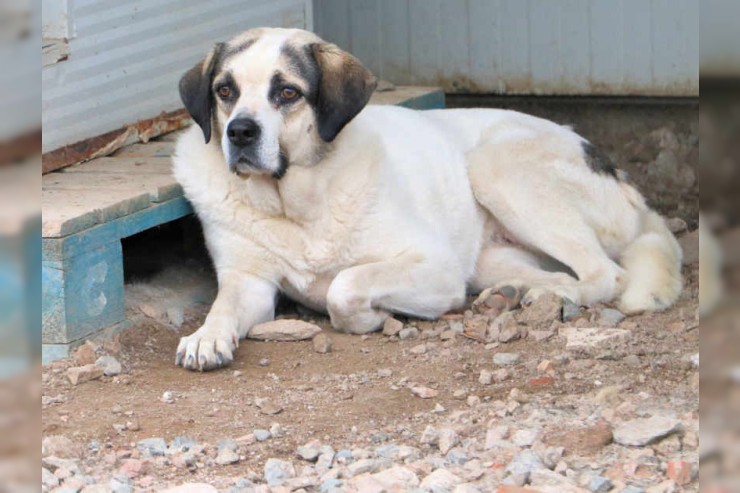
[173,28,682,371]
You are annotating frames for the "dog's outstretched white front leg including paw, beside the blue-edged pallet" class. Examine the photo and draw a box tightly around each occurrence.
[175,274,277,371]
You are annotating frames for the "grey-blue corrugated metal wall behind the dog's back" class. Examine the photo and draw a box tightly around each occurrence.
[314,0,699,96]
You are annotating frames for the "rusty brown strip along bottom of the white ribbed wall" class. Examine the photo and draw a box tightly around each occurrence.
[41,109,192,174]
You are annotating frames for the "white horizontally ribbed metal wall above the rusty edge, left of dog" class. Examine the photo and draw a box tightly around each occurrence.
[42,0,313,152]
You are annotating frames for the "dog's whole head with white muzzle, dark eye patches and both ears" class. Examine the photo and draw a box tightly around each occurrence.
[180,29,376,178]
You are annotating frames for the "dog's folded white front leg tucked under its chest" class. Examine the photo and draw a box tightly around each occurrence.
[326,254,465,334]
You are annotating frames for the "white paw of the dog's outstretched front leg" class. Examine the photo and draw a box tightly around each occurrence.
[175,325,239,371]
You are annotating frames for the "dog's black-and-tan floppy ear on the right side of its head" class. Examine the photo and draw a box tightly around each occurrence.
[311,43,378,142]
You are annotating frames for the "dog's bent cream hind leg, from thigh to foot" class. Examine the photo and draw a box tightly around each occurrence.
[468,141,624,304]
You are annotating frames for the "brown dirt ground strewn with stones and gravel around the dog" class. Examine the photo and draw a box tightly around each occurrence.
[42,98,699,493]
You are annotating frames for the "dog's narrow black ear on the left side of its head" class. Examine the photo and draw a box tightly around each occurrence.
[180,43,224,143]
